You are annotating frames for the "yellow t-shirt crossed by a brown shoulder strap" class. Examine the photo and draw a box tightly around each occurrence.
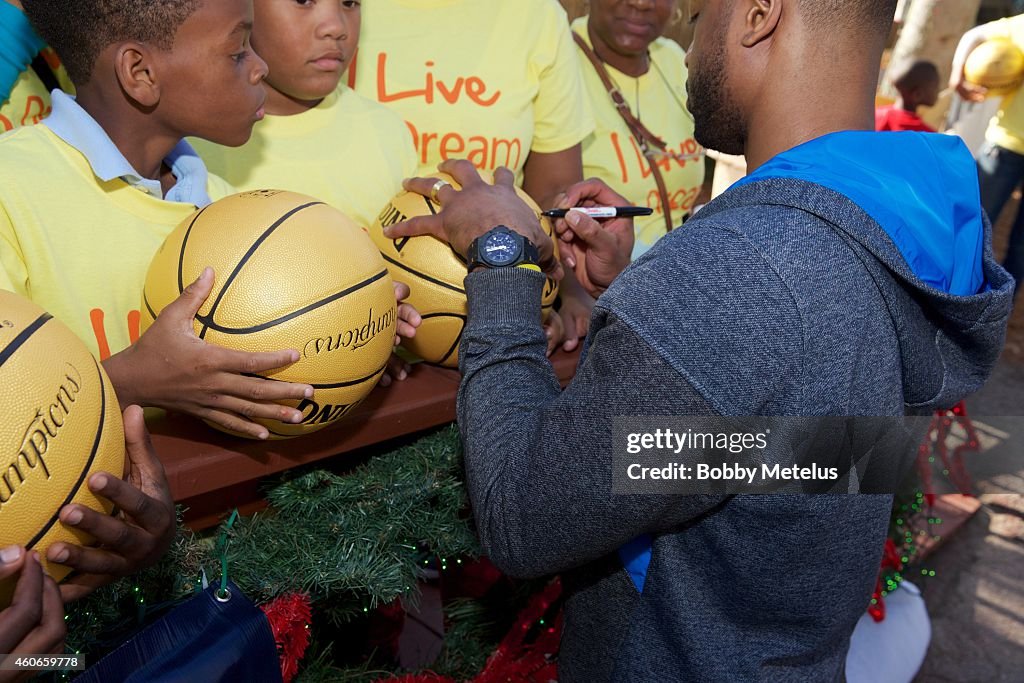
[572,16,705,258]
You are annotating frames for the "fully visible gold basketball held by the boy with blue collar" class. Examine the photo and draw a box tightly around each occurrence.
[142,189,397,438]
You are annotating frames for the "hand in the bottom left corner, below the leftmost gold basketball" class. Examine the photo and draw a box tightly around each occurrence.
[0,546,67,683]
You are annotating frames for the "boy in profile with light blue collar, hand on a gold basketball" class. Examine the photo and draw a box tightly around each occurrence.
[0,0,411,438]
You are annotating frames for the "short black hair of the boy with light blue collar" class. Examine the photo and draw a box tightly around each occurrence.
[22,0,203,86]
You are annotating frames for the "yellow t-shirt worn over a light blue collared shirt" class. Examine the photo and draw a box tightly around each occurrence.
[0,126,228,359]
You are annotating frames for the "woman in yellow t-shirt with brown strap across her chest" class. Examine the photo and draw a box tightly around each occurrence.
[572,0,705,258]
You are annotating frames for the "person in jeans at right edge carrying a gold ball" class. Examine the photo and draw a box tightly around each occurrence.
[949,14,1024,296]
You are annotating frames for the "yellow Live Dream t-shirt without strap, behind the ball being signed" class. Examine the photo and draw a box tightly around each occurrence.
[349,0,593,180]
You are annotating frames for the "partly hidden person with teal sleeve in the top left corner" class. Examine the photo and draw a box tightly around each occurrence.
[0,0,75,133]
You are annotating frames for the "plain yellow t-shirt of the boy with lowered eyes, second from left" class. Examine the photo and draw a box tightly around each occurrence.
[189,86,417,227]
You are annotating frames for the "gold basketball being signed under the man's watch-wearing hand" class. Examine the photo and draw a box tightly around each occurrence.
[370,173,558,368]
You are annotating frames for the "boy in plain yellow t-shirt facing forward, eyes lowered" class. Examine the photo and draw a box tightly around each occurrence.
[195,0,417,232]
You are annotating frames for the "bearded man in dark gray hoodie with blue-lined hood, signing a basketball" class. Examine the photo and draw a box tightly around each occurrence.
[388,0,1013,683]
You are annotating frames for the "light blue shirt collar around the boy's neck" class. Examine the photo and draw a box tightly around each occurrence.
[42,90,211,208]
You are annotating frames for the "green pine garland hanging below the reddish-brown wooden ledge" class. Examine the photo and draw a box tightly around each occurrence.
[59,426,479,680]
